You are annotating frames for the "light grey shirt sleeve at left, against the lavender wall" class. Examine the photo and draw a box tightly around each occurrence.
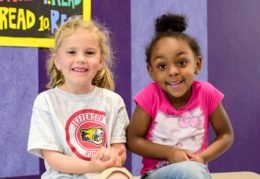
[27,94,62,158]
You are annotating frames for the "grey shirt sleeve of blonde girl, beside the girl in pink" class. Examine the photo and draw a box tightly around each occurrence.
[111,97,129,144]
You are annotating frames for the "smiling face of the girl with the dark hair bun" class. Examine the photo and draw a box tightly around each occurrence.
[147,37,201,103]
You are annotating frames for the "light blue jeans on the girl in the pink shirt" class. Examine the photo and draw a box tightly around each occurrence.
[142,161,211,179]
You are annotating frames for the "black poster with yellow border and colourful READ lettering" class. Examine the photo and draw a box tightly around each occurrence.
[0,0,91,48]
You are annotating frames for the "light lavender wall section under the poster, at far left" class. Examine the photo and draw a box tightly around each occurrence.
[0,47,39,178]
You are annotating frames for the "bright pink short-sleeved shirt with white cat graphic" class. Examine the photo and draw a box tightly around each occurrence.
[134,81,224,174]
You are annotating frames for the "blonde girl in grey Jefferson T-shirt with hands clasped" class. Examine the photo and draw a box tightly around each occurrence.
[28,18,131,179]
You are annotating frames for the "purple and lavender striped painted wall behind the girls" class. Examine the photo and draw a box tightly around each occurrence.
[0,0,260,179]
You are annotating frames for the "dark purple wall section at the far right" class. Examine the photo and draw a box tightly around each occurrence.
[208,0,260,173]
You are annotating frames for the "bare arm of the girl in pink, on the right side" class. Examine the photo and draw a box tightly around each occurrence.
[195,103,234,163]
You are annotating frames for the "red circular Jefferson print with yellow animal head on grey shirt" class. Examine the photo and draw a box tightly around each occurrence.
[65,109,106,160]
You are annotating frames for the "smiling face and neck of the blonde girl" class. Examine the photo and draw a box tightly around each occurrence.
[54,29,104,94]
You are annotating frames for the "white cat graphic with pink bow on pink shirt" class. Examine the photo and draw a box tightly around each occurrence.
[150,107,205,152]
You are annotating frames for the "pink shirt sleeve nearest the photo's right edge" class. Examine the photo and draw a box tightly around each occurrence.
[204,82,224,114]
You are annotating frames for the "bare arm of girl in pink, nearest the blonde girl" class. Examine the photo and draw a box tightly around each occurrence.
[127,105,189,163]
